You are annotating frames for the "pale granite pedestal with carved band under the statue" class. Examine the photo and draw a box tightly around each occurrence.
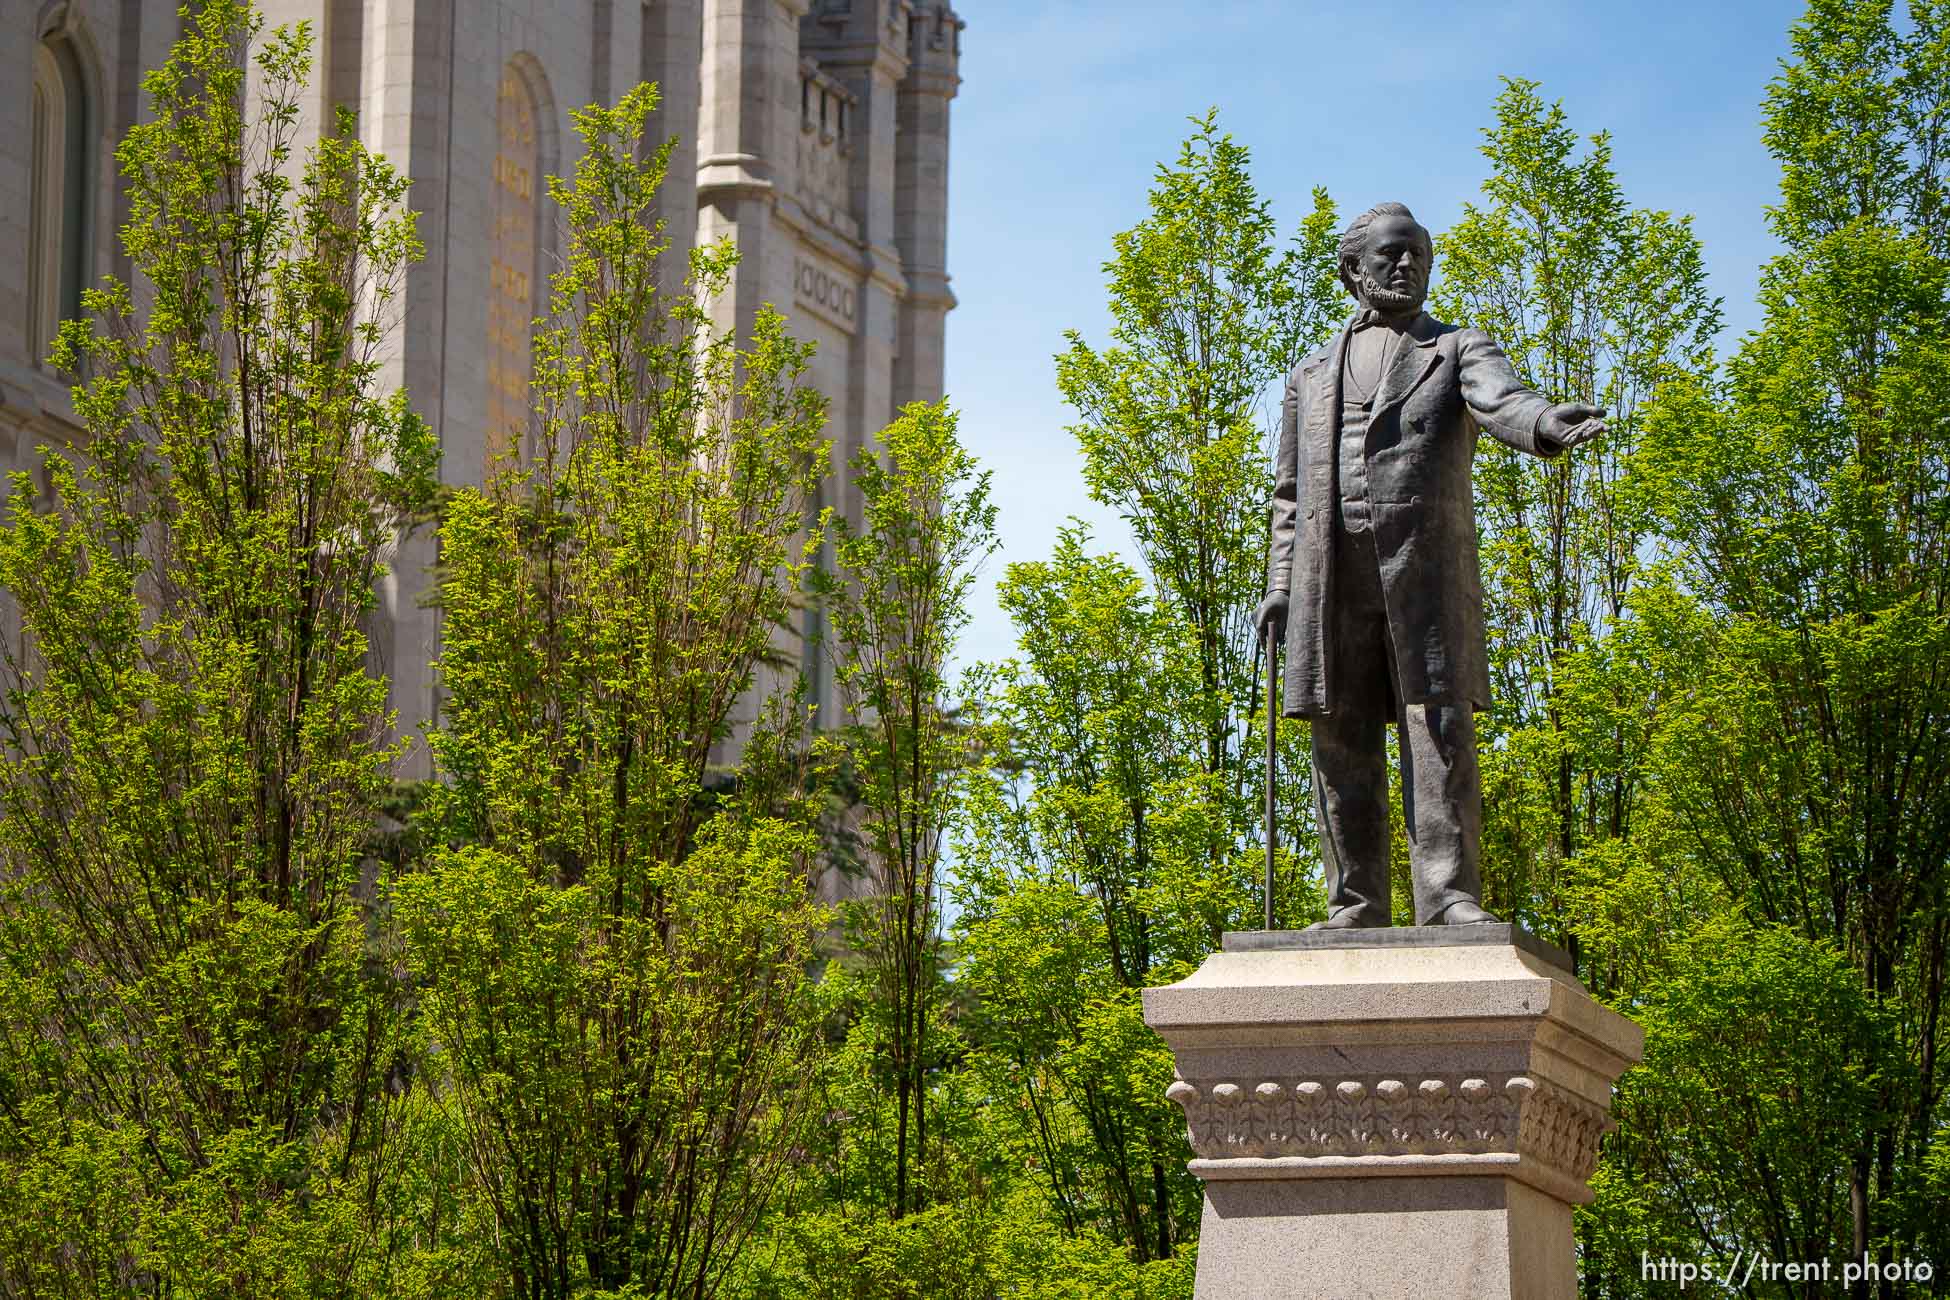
[1145,924,1644,1300]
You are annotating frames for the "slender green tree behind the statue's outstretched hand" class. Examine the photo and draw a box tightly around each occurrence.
[1431,80,1720,949]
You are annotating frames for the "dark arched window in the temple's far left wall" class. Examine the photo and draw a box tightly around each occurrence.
[27,37,92,363]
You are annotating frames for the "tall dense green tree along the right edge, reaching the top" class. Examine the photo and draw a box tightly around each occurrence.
[1634,0,1950,1296]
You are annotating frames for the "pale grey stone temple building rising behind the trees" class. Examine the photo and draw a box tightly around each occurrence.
[0,0,961,776]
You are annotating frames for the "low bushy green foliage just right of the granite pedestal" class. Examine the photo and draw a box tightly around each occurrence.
[1583,912,1892,1300]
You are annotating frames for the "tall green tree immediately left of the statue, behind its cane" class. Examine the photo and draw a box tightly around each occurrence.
[1057,111,1342,845]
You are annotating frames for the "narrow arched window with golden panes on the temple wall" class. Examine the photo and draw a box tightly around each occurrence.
[486,64,542,472]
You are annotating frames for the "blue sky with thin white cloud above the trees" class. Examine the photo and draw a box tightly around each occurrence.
[948,0,1802,661]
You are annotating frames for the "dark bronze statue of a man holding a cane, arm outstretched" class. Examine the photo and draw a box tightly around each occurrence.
[1258,203,1605,930]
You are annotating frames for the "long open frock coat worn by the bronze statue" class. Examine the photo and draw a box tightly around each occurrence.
[1266,314,1564,717]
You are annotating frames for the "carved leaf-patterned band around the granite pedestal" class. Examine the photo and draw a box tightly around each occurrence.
[1164,1074,1613,1181]
